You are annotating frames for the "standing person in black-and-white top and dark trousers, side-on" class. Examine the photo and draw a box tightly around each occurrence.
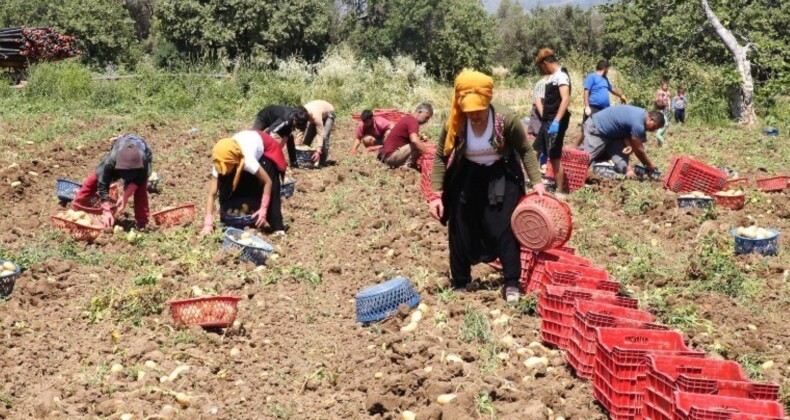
[532,48,571,193]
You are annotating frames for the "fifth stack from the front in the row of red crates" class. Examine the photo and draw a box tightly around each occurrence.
[538,284,638,350]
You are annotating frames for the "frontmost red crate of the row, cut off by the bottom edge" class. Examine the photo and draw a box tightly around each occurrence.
[674,392,786,420]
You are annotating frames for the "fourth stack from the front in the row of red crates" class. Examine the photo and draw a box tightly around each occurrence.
[566,300,667,379]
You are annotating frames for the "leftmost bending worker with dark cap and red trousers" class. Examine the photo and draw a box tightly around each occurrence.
[74,134,153,229]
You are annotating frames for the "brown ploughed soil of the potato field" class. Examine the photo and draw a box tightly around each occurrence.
[0,77,790,419]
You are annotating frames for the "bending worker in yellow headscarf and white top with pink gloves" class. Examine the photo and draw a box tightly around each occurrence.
[200,130,286,236]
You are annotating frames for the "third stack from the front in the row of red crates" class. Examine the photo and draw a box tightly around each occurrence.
[593,328,705,420]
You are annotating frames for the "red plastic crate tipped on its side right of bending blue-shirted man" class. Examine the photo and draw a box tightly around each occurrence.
[664,156,727,195]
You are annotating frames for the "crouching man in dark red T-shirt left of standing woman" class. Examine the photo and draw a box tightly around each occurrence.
[378,103,433,168]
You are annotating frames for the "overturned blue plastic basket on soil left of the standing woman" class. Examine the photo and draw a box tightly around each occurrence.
[356,277,420,323]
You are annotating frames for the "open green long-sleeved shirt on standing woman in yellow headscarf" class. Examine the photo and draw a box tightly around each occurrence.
[431,104,541,191]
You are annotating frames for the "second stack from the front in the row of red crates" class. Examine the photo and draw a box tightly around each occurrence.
[643,355,779,420]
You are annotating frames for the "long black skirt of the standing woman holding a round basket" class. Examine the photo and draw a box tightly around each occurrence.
[448,161,523,287]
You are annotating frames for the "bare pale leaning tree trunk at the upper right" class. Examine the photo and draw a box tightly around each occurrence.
[700,0,757,125]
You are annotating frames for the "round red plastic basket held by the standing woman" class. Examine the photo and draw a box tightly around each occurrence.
[510,193,573,251]
